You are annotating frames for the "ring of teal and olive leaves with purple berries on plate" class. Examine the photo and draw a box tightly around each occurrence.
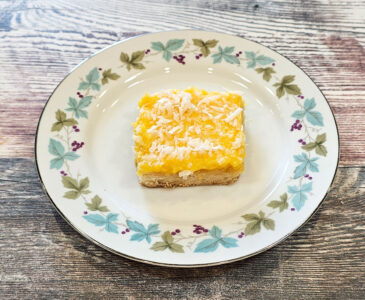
[48,38,327,253]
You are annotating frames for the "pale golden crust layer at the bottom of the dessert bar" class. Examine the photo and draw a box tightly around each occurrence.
[139,170,241,188]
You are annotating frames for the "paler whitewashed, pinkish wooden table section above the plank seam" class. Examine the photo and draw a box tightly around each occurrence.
[0,0,365,166]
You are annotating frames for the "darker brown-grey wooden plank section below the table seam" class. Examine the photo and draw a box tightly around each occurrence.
[0,158,365,299]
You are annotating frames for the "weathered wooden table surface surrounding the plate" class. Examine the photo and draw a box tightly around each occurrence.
[0,0,365,299]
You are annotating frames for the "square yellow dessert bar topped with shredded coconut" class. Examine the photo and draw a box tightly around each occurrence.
[133,88,245,187]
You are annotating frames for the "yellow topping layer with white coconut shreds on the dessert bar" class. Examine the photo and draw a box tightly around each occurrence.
[133,90,244,173]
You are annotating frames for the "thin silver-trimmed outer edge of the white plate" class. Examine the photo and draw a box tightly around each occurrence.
[34,29,341,268]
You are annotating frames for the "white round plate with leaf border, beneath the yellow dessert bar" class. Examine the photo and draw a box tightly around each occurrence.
[36,30,339,267]
